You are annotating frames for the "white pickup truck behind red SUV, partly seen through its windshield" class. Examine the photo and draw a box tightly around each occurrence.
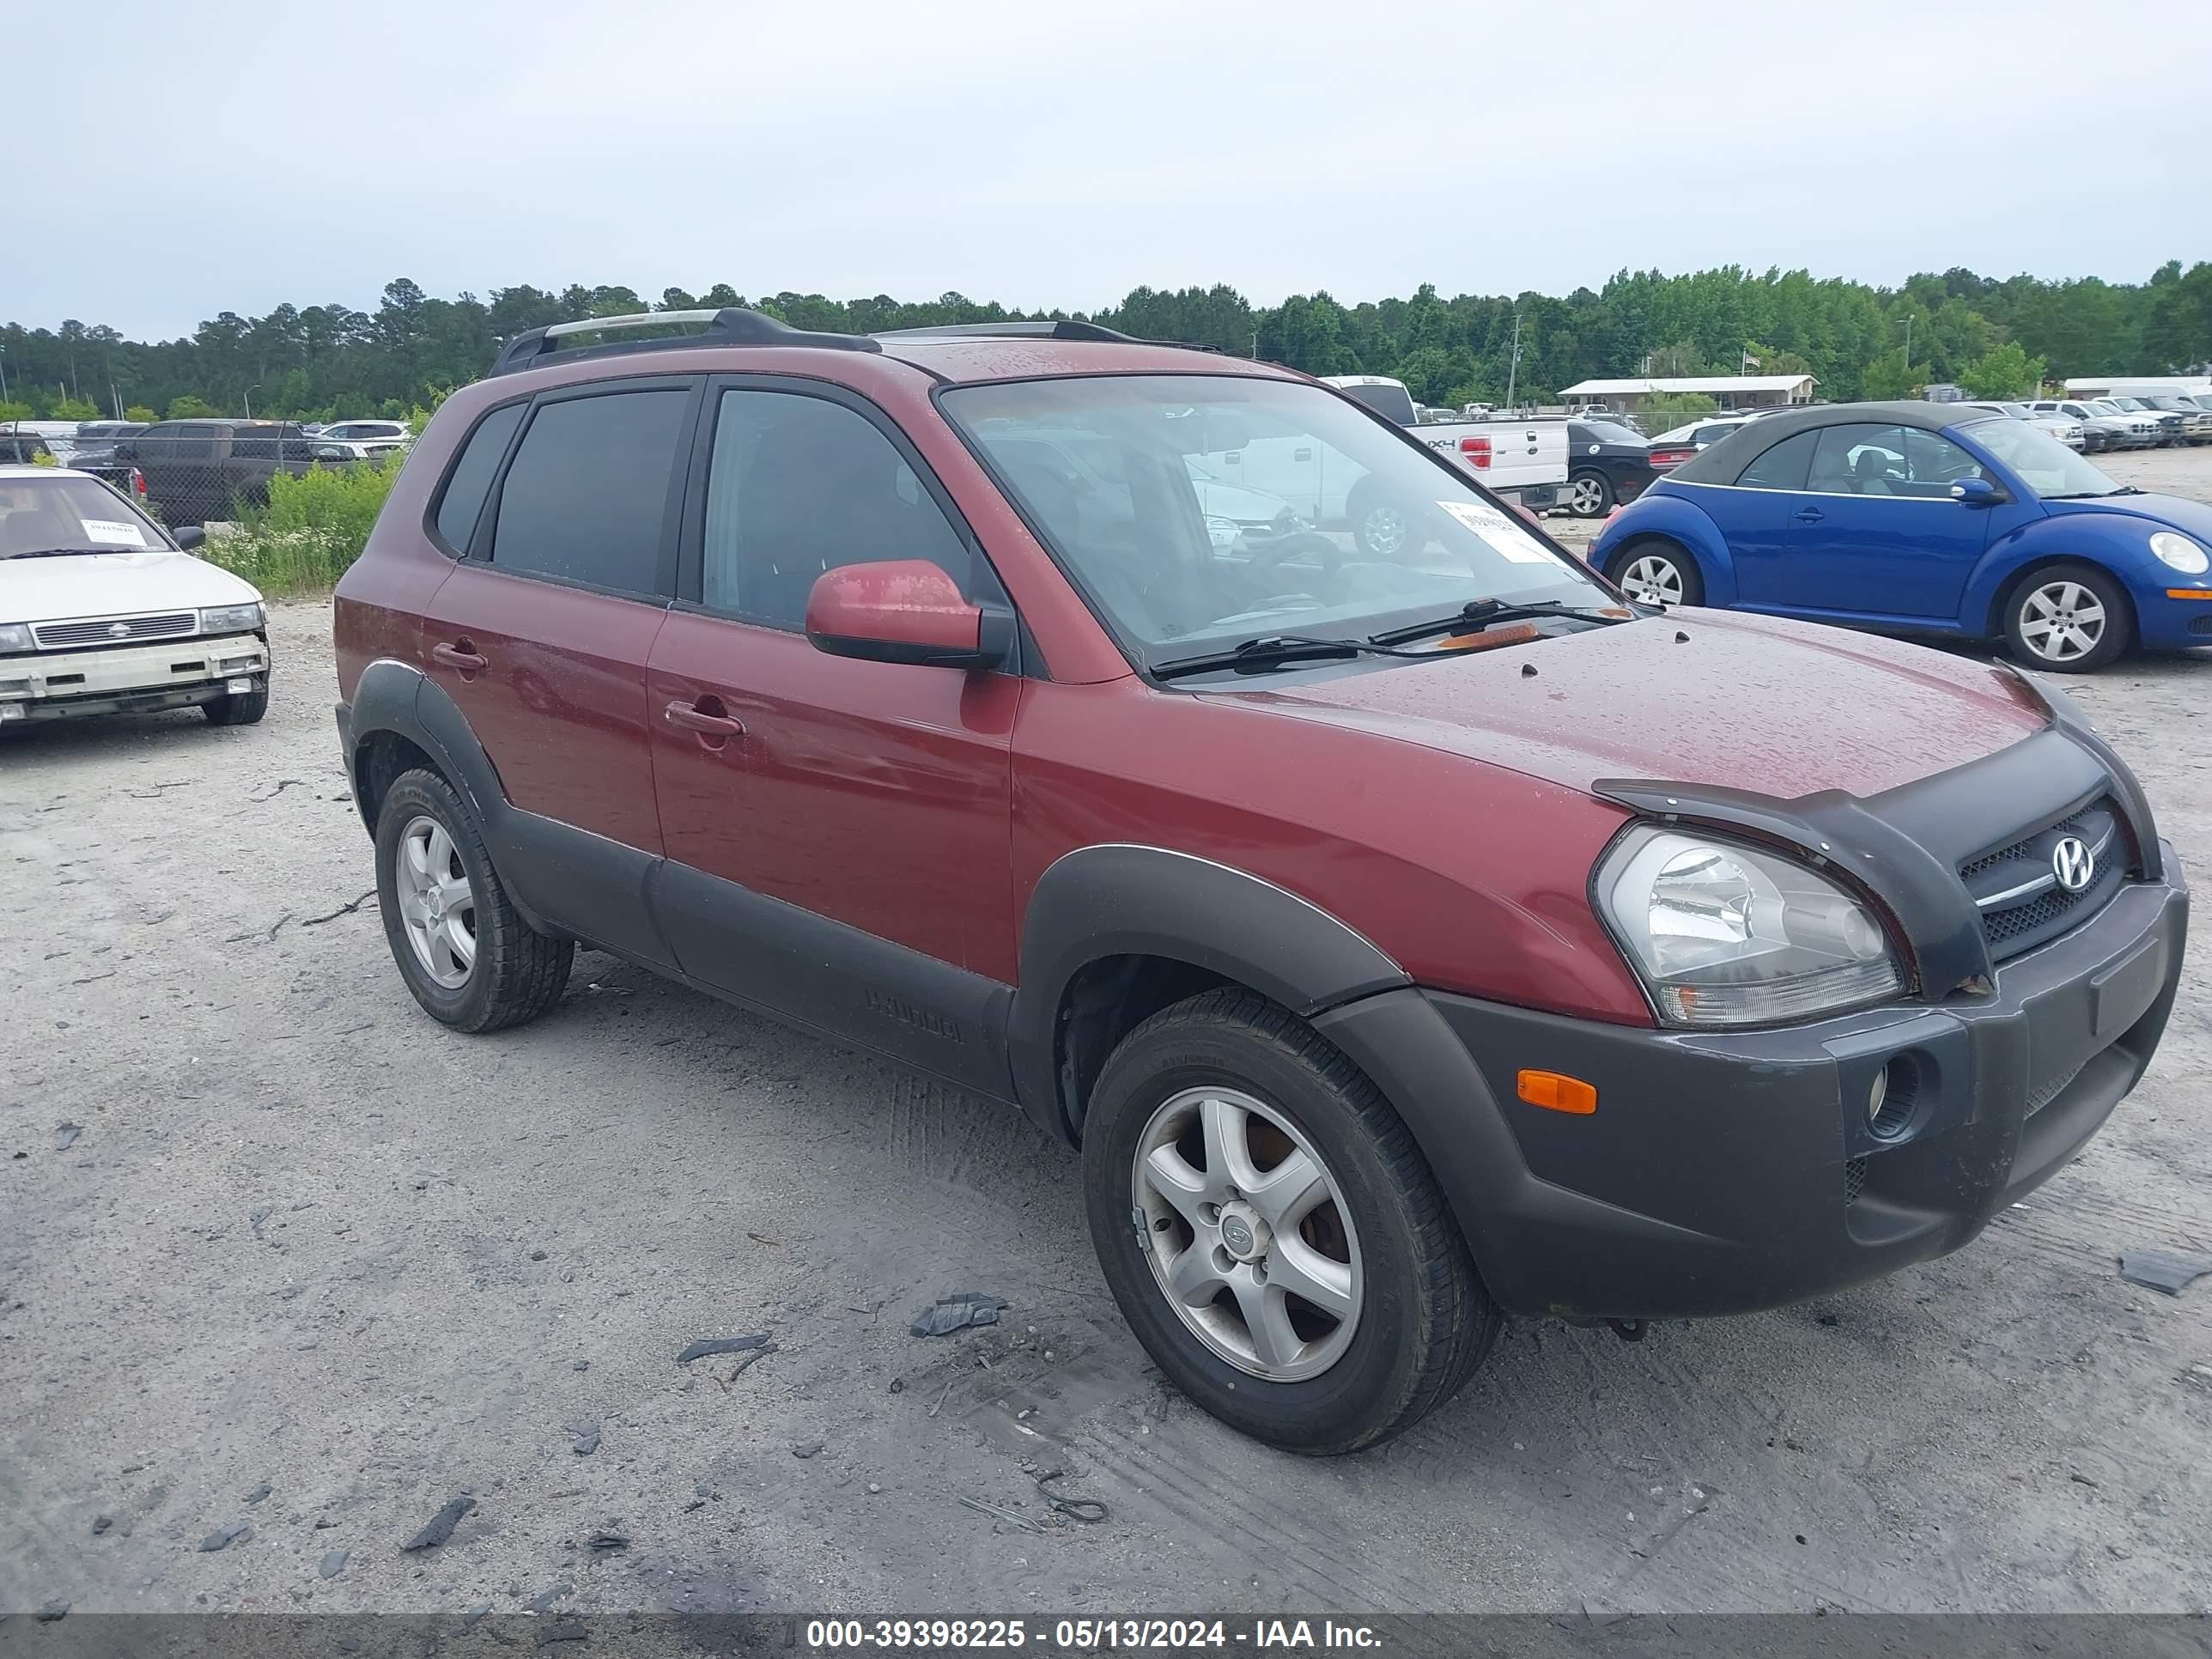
[1206,374,1566,557]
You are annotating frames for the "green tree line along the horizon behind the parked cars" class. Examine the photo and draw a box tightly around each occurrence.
[0,261,2212,420]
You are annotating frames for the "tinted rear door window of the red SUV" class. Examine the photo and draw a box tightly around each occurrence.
[491,387,690,592]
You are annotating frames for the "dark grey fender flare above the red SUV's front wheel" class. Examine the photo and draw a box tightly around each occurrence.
[1006,842,1411,1139]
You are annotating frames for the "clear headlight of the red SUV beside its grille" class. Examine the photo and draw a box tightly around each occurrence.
[1597,827,1905,1026]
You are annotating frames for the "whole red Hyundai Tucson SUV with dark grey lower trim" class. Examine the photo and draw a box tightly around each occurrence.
[337,310,2188,1451]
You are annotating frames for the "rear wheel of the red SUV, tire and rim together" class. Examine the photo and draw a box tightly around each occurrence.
[376,769,575,1030]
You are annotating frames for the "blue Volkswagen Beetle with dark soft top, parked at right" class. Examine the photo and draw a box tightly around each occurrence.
[1590,403,2212,672]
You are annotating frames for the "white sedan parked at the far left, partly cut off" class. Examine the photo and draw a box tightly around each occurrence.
[0,467,270,728]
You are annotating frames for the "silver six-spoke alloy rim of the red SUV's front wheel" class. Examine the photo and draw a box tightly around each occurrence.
[1133,1088,1363,1382]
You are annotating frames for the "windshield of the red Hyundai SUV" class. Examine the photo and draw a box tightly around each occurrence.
[940,374,1614,668]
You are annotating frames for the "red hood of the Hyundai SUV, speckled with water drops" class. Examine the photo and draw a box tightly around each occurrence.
[1206,611,2048,805]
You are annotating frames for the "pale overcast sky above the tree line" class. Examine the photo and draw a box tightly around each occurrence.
[17,0,2212,338]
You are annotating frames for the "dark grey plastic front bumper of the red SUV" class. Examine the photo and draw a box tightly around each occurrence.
[1316,848,2188,1318]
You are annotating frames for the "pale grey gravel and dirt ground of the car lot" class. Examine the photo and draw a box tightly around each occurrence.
[0,452,2212,1613]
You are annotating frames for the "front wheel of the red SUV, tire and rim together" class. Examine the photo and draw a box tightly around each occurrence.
[1084,991,1500,1455]
